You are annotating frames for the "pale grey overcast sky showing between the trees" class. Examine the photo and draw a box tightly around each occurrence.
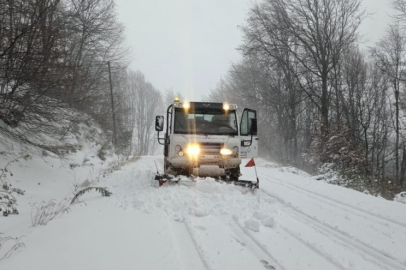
[116,0,391,101]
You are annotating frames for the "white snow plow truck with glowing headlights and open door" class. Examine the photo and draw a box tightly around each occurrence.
[155,99,258,189]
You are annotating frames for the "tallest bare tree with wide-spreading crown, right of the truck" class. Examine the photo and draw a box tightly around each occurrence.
[244,0,364,137]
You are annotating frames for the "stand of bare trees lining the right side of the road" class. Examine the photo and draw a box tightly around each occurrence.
[208,0,406,198]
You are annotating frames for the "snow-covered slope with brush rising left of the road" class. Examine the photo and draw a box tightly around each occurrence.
[0,108,117,242]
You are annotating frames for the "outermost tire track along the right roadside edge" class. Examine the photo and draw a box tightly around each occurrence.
[258,172,406,229]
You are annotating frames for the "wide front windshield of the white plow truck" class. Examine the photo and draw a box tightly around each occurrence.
[174,108,238,135]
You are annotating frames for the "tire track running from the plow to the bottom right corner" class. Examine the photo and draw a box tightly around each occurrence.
[261,188,406,270]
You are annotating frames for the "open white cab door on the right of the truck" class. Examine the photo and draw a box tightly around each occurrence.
[240,108,258,158]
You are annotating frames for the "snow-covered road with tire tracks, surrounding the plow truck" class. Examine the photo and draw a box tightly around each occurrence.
[1,157,406,270]
